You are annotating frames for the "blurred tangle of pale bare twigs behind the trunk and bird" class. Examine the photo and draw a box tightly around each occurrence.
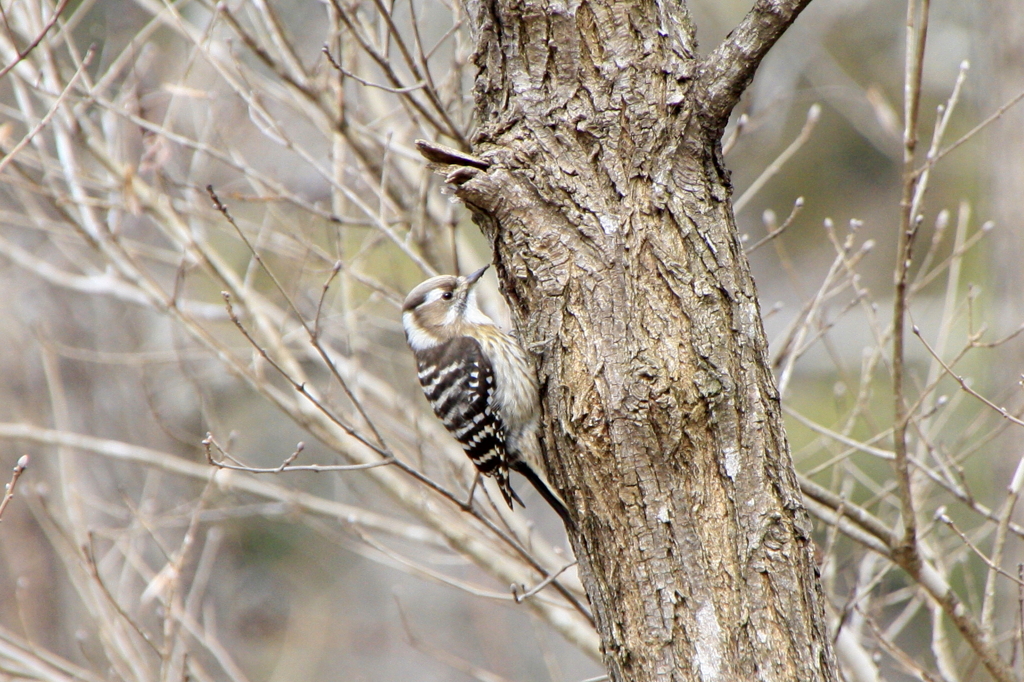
[0,0,1024,682]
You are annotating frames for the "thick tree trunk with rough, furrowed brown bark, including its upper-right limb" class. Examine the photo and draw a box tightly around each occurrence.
[422,0,838,682]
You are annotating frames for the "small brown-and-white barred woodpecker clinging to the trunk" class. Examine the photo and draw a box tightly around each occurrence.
[401,265,572,527]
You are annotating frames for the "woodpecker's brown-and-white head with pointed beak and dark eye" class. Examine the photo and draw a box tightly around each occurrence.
[401,265,494,350]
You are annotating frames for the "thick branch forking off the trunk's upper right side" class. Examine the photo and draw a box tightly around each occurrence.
[698,0,811,127]
